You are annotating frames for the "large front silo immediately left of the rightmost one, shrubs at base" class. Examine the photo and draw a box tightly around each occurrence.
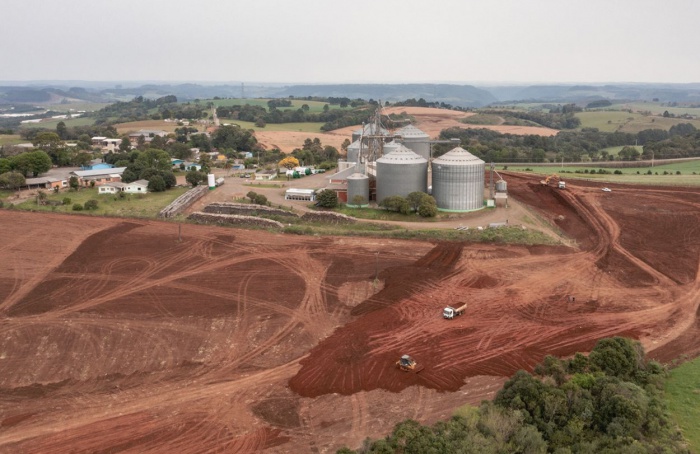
[377,145,428,203]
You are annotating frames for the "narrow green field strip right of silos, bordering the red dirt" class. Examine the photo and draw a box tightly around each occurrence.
[506,160,700,186]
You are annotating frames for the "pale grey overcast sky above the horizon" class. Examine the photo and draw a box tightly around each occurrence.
[0,0,700,84]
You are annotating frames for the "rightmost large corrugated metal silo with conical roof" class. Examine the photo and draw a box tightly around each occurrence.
[432,147,484,211]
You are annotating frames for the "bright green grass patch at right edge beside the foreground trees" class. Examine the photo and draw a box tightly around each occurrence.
[666,358,700,452]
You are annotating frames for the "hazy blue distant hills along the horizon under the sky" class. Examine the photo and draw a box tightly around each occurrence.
[0,81,700,107]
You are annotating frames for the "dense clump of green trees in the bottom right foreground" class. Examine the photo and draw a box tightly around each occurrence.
[338,337,689,454]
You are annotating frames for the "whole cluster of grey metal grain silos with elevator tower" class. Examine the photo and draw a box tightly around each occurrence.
[328,109,507,212]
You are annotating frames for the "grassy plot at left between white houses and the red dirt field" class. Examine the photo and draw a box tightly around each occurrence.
[11,188,189,218]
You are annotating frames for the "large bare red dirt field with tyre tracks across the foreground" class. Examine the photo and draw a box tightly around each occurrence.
[0,174,700,453]
